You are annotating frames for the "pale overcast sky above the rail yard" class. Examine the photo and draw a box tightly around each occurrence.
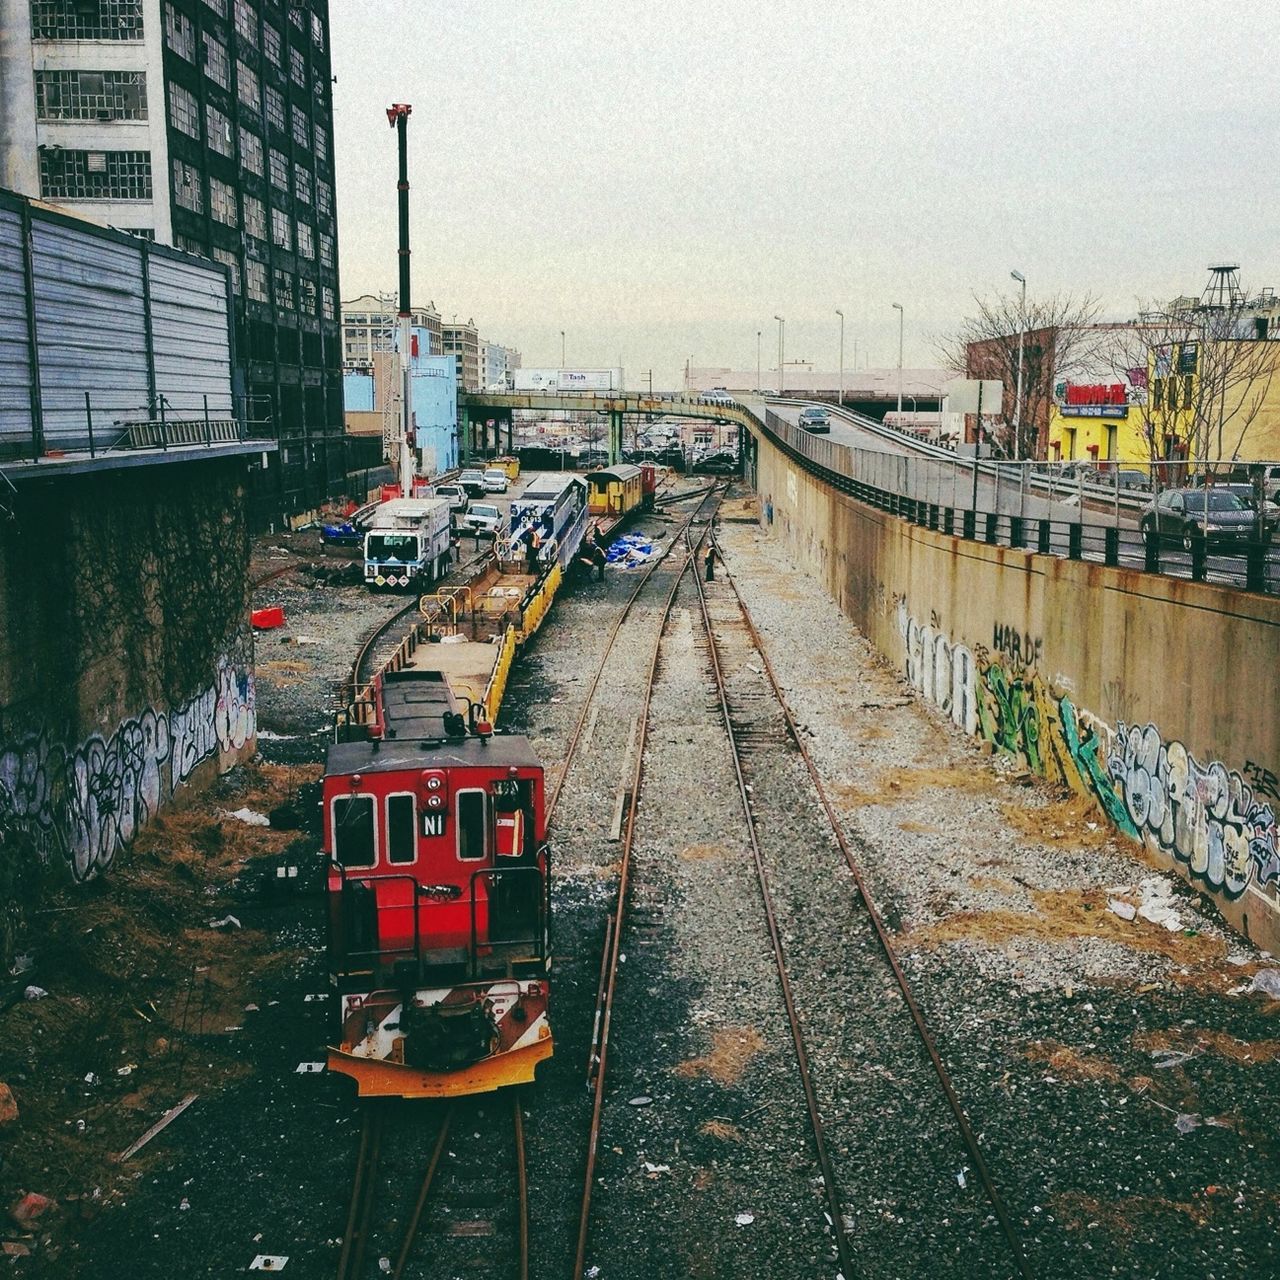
[330,0,1280,387]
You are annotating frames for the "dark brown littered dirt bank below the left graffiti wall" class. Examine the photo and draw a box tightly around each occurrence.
[0,764,319,1260]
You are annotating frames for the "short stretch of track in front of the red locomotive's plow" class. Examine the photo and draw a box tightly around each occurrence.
[337,1091,529,1280]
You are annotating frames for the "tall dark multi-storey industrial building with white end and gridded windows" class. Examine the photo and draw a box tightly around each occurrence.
[0,0,348,522]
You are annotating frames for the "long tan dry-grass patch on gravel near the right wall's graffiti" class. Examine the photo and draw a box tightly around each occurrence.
[902,888,1243,991]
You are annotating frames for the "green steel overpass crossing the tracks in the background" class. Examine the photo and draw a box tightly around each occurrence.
[458,392,763,465]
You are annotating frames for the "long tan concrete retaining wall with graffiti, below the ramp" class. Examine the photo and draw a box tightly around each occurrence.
[756,435,1280,950]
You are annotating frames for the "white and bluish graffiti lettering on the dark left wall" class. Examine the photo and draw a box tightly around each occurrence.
[0,658,255,879]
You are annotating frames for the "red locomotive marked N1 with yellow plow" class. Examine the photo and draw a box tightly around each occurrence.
[323,671,552,1097]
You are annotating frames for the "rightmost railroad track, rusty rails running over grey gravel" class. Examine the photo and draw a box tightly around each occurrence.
[694,532,1032,1280]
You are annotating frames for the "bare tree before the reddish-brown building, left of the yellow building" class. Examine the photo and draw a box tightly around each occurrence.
[936,293,1101,458]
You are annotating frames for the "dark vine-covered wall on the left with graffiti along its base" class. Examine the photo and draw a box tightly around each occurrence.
[0,460,255,879]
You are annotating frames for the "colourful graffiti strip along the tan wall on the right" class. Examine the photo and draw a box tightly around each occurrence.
[897,598,1280,897]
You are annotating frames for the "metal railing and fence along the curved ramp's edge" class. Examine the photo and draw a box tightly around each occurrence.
[751,408,1280,594]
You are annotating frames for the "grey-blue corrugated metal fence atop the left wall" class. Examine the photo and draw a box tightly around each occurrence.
[0,192,233,458]
